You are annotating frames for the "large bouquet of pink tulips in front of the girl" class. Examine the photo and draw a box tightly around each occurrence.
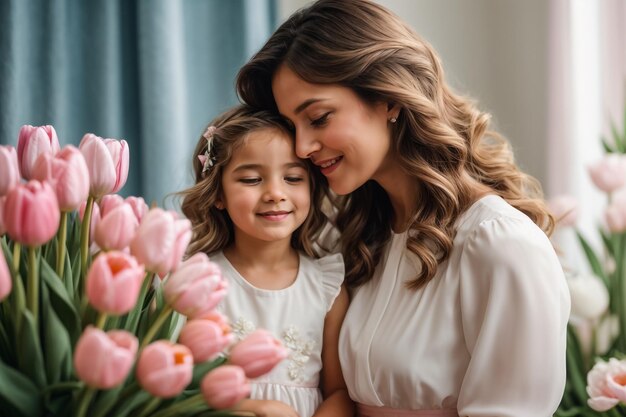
[0,126,286,417]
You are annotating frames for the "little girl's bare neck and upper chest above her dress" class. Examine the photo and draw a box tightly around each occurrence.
[224,240,300,290]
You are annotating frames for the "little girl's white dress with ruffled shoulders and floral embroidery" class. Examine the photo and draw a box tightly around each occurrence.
[211,252,344,417]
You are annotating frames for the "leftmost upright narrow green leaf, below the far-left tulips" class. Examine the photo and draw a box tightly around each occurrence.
[17,310,46,387]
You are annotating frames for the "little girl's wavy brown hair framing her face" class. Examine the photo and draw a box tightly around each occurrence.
[178,105,328,257]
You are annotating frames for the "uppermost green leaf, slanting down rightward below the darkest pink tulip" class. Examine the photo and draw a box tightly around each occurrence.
[41,261,82,345]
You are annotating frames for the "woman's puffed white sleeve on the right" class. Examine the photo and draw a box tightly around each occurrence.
[458,217,570,417]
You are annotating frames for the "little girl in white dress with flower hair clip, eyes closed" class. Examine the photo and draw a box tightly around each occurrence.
[182,106,353,417]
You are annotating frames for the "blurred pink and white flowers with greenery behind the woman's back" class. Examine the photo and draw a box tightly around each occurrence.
[550,118,626,417]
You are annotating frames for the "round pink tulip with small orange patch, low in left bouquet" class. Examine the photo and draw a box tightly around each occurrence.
[137,340,193,398]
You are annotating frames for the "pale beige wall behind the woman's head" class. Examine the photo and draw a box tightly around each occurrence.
[278,0,549,184]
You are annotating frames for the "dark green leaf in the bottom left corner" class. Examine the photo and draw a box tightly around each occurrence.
[0,361,42,417]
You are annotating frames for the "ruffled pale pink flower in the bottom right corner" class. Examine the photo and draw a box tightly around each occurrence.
[587,358,626,411]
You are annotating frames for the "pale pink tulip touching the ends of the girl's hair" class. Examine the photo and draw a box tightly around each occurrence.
[130,207,191,276]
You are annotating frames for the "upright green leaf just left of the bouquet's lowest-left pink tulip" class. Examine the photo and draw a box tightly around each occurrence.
[41,286,72,383]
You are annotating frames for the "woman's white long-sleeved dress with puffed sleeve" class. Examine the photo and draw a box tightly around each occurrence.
[339,195,570,417]
